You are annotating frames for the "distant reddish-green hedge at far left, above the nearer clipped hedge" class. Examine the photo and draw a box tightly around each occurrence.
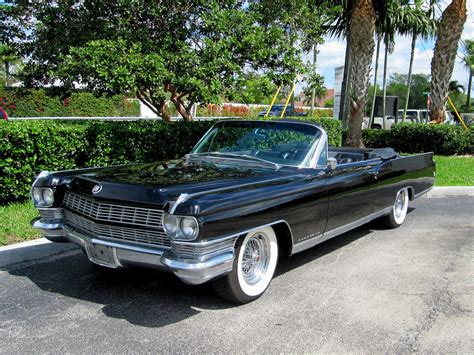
[0,88,140,117]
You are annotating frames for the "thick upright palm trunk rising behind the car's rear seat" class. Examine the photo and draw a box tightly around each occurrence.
[345,0,375,147]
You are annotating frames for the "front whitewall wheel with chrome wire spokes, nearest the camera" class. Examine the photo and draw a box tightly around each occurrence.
[213,227,278,304]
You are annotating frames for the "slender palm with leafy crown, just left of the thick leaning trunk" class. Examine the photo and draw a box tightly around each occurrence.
[401,0,436,122]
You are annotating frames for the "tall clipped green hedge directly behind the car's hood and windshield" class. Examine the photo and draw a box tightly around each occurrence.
[0,119,341,204]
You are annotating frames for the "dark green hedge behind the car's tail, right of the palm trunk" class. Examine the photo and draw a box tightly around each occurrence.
[363,123,474,155]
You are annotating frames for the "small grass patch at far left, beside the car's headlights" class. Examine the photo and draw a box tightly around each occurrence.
[0,202,41,245]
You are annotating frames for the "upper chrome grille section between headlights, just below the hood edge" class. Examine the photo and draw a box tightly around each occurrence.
[63,192,163,229]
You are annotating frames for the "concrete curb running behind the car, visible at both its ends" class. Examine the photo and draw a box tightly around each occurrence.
[0,186,474,270]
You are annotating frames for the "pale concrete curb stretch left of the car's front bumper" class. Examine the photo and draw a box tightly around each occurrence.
[0,238,79,270]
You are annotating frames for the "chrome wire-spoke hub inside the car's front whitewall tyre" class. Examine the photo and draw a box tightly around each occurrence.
[242,234,270,285]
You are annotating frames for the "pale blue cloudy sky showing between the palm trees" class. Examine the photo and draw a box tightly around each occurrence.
[308,0,474,94]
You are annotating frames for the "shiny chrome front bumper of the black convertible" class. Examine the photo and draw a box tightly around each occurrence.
[32,219,237,285]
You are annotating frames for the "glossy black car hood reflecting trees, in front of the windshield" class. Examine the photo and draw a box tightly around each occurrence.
[40,159,308,211]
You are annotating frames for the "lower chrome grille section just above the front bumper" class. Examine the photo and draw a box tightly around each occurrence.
[64,210,171,248]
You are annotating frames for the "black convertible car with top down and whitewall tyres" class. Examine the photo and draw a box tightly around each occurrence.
[32,120,435,303]
